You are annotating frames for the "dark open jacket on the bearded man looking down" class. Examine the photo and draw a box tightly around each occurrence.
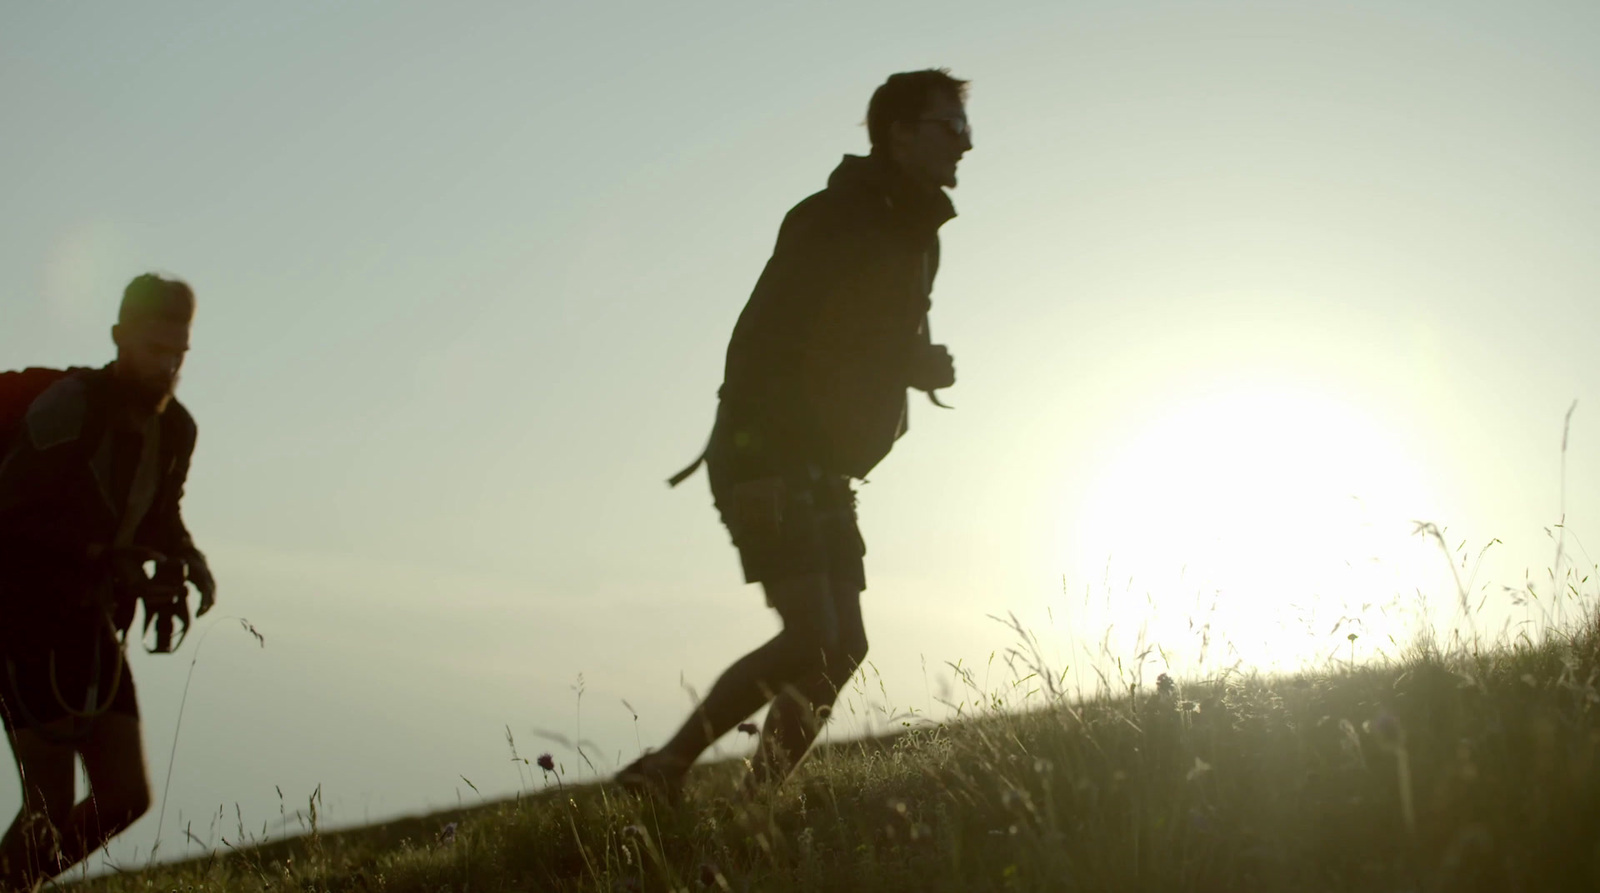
[0,366,195,647]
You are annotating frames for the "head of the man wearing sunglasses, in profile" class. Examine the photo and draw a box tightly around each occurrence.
[867,69,973,189]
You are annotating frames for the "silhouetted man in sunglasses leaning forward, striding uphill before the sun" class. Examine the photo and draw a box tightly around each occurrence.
[618,69,973,799]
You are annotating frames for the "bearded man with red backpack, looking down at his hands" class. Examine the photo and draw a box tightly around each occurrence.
[0,275,216,890]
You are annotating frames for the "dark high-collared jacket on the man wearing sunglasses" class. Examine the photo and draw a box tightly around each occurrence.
[707,155,955,480]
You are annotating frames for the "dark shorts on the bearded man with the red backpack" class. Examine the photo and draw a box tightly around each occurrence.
[0,632,139,731]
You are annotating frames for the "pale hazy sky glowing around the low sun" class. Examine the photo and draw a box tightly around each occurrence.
[0,0,1600,863]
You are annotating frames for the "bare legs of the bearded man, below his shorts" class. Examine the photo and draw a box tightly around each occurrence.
[0,714,150,888]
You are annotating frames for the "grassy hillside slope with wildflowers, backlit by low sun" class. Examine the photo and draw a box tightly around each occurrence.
[72,614,1600,893]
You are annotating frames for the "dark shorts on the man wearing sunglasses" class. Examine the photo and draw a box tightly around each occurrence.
[707,466,867,592]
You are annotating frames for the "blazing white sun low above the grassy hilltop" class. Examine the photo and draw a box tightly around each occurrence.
[1066,387,1438,672]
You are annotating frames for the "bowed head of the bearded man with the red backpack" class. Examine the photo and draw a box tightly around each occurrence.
[110,274,195,411]
